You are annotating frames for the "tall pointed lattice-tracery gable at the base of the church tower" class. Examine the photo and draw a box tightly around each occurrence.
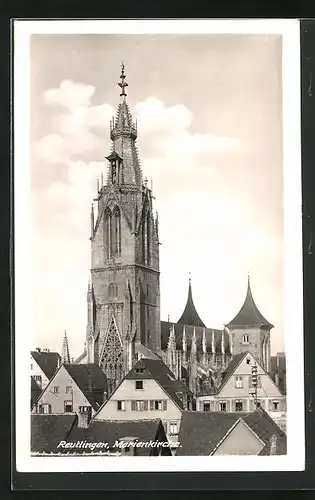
[101,317,124,392]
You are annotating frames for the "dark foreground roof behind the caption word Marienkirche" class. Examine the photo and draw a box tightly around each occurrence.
[63,419,171,455]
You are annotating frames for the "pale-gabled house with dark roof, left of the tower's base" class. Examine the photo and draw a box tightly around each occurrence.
[33,364,107,415]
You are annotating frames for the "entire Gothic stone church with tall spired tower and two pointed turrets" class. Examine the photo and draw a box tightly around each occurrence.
[76,66,273,394]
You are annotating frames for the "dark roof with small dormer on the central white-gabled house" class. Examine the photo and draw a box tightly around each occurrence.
[125,358,192,409]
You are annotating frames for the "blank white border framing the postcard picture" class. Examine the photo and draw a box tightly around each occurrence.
[13,19,305,472]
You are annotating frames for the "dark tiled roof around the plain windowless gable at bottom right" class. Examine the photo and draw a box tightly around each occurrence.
[177,408,286,456]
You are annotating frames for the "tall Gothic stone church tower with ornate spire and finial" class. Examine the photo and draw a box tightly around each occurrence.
[86,64,161,391]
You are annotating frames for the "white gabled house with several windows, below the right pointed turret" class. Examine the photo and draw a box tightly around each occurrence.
[196,352,286,431]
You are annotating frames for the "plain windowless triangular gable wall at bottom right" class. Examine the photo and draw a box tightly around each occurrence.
[211,419,265,455]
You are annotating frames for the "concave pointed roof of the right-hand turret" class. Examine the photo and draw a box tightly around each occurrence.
[226,278,273,329]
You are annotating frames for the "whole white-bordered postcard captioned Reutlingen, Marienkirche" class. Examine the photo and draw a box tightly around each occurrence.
[14,20,304,472]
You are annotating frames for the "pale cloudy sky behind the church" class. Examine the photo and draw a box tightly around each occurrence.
[31,35,284,357]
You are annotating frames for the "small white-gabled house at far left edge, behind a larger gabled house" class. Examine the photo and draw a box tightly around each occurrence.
[30,347,61,390]
